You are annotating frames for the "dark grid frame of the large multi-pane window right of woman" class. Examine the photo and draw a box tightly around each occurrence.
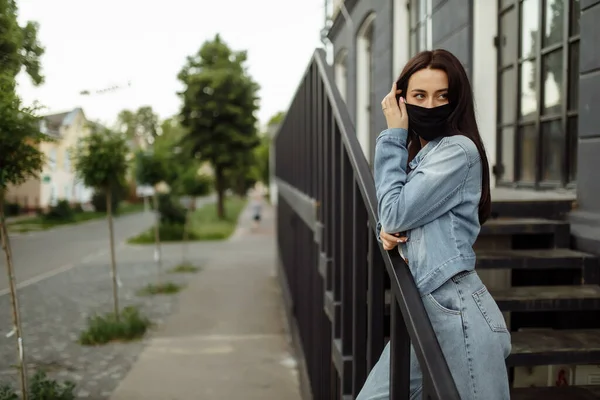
[494,0,580,189]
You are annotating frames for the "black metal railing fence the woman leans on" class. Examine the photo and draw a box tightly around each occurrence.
[274,49,459,400]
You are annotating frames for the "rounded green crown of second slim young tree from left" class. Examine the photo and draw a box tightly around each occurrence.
[74,126,129,190]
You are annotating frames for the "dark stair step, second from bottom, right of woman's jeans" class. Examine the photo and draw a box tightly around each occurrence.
[507,329,600,367]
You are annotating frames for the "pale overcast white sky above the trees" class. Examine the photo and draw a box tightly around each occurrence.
[17,0,325,127]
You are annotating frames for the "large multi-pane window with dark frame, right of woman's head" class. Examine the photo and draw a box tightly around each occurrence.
[494,0,580,187]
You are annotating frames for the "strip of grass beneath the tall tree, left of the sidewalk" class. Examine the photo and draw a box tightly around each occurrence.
[128,197,246,244]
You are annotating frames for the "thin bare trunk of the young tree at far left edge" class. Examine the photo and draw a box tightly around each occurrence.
[0,191,27,400]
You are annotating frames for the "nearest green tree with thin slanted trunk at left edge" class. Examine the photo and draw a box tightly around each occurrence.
[0,0,44,400]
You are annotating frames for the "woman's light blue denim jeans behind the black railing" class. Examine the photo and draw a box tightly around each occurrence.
[356,271,511,400]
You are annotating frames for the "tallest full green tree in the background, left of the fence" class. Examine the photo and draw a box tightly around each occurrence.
[178,35,259,218]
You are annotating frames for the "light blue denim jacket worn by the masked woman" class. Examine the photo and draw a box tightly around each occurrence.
[374,128,482,295]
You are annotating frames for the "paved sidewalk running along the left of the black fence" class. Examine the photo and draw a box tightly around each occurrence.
[111,202,300,400]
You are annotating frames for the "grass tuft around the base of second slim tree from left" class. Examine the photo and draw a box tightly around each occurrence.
[79,307,151,346]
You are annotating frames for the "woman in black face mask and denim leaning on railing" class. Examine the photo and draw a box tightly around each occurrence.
[357,50,511,400]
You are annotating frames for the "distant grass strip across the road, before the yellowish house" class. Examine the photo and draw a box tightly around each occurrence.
[8,203,144,233]
